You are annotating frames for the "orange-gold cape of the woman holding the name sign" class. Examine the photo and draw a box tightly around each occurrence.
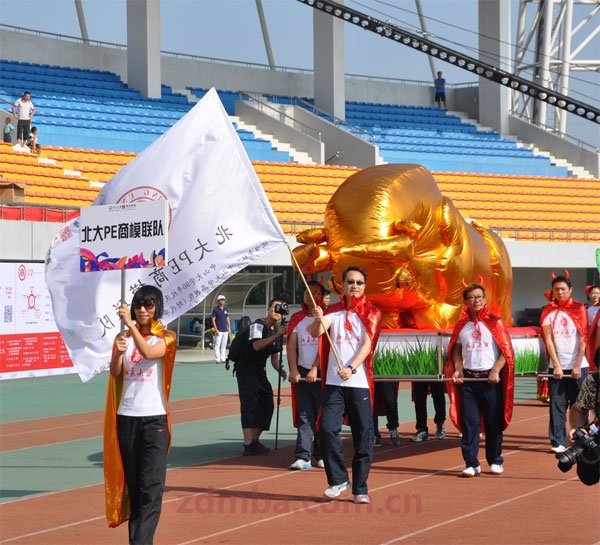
[104,321,177,528]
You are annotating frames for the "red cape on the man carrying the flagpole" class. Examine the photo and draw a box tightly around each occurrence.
[319,295,381,414]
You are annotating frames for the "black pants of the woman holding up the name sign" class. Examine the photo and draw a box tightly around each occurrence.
[117,414,169,545]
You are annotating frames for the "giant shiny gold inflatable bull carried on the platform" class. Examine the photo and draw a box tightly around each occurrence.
[294,165,512,329]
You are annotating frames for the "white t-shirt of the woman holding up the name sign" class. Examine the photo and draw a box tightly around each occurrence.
[117,335,167,416]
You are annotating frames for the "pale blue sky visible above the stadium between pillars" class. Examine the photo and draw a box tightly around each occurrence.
[0,0,600,143]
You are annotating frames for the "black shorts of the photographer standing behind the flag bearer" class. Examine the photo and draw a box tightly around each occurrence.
[237,374,275,430]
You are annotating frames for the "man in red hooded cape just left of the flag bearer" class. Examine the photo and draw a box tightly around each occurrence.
[287,280,325,469]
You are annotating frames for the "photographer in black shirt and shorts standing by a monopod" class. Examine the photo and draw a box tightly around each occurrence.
[236,299,287,456]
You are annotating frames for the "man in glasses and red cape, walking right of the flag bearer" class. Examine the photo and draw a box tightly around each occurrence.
[444,284,514,477]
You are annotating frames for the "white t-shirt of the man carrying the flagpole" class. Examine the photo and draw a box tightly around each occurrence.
[326,310,369,388]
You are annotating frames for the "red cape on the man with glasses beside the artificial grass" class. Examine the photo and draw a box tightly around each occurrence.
[444,307,515,432]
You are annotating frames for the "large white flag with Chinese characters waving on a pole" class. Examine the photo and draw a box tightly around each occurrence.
[46,89,286,381]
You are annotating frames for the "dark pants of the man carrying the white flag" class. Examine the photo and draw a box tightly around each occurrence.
[319,385,373,494]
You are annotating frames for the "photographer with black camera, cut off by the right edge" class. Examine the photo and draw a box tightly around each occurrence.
[569,371,600,486]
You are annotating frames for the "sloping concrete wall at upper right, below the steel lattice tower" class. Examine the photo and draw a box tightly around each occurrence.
[508,115,600,178]
